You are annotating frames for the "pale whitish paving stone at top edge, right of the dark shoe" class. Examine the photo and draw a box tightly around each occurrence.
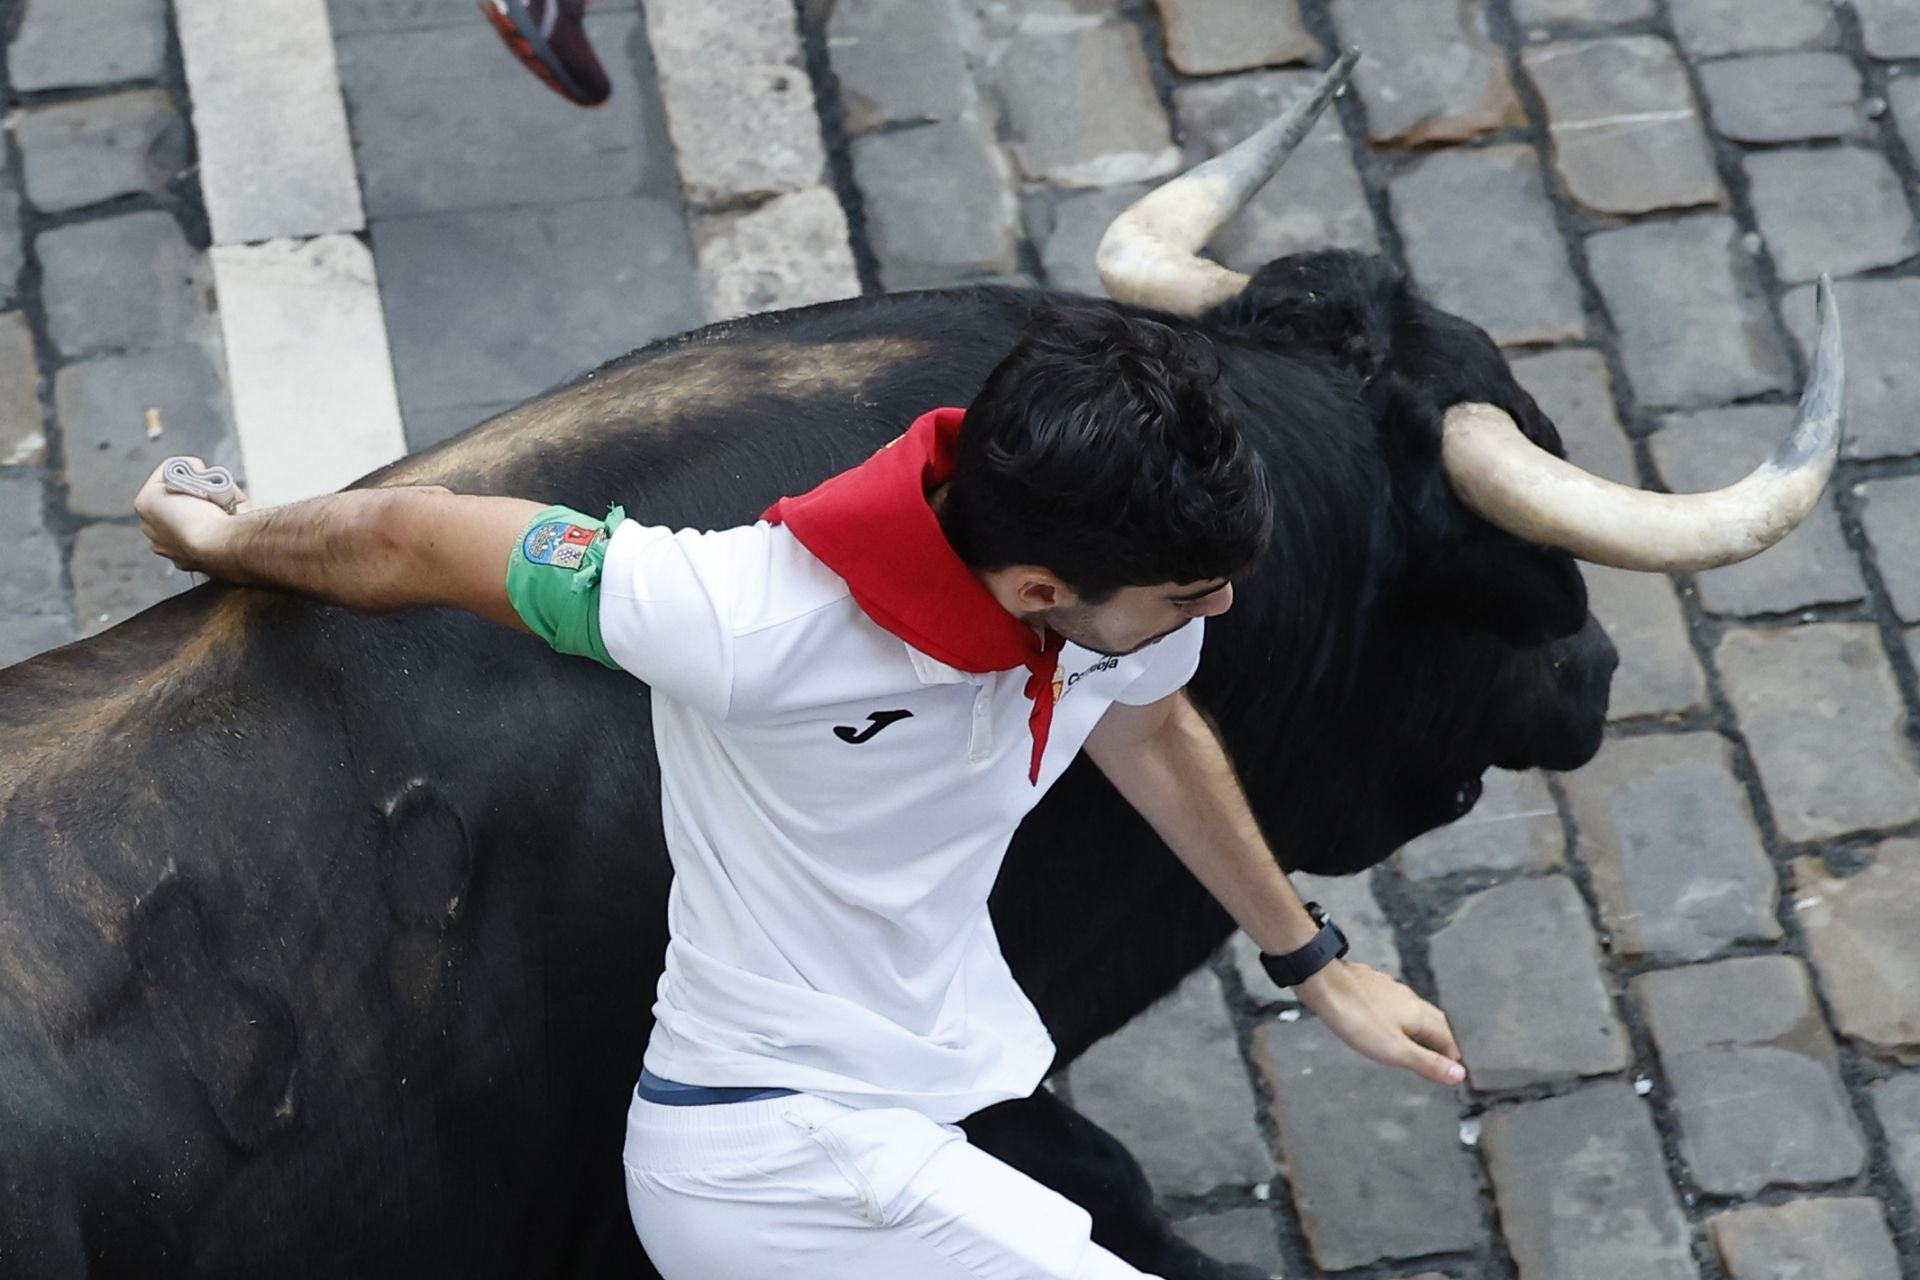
[645,0,826,205]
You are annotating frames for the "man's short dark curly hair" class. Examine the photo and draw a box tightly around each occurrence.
[941,305,1273,604]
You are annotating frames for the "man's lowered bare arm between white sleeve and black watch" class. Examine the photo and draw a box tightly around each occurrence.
[1089,699,1319,954]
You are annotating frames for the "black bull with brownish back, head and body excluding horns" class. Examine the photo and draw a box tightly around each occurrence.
[0,255,1615,1278]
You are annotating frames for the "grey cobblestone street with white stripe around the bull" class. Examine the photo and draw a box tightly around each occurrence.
[0,0,1920,1280]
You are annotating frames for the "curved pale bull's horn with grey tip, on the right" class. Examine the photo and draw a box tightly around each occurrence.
[1440,276,1847,574]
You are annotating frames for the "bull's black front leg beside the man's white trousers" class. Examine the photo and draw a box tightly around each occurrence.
[960,1088,1267,1280]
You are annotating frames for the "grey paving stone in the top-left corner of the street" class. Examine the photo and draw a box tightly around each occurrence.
[6,0,167,92]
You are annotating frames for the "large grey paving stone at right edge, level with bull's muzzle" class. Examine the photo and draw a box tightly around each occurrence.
[1718,622,1920,844]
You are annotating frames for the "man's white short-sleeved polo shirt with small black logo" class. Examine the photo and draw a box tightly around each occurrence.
[599,520,1202,1121]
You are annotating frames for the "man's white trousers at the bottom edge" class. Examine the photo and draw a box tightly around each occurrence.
[626,1094,1150,1280]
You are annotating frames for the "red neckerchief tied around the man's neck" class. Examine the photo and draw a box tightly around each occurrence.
[762,409,1066,785]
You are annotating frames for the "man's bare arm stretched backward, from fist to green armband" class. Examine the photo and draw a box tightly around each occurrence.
[134,459,541,631]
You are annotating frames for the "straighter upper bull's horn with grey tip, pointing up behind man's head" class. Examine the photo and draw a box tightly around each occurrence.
[1094,50,1359,315]
